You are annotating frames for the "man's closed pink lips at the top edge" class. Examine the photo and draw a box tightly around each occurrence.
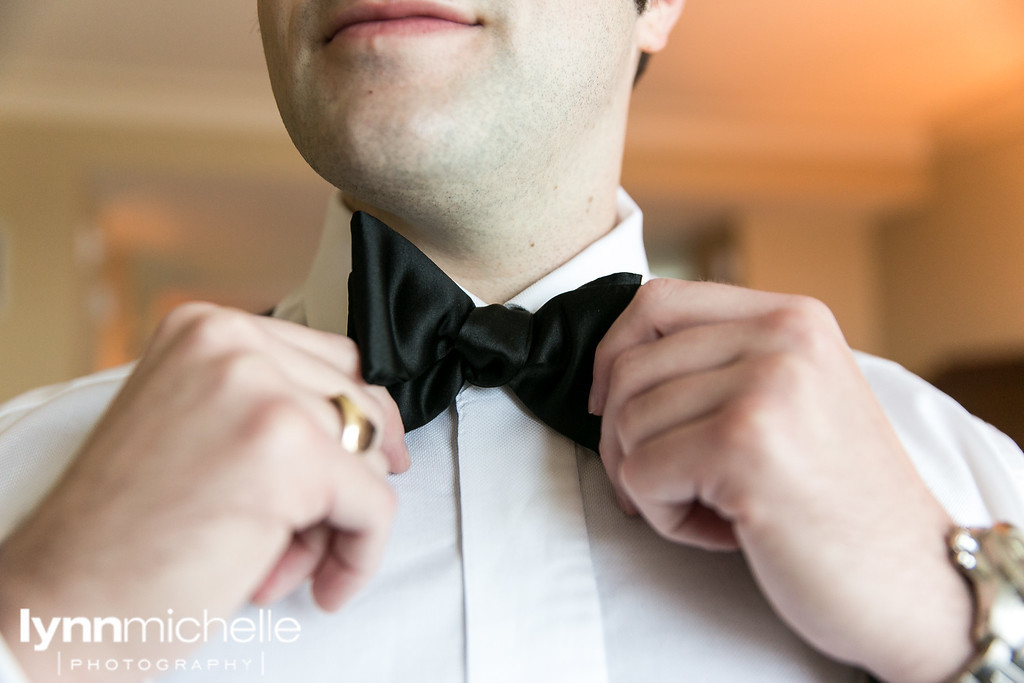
[325,0,479,43]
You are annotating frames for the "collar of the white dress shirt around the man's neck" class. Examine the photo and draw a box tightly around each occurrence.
[274,188,650,334]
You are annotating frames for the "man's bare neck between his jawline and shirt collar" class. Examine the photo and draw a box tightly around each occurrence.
[343,88,628,303]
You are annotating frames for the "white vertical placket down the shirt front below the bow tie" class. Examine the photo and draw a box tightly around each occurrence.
[456,386,607,683]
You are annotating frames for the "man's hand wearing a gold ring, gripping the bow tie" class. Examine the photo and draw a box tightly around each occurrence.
[0,304,409,680]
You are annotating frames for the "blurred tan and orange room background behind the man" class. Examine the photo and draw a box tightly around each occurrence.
[0,0,1024,442]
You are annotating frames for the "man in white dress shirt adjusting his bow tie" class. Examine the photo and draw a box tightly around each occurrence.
[0,0,1024,682]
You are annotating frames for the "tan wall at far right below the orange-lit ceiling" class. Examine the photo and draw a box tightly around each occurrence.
[878,94,1024,376]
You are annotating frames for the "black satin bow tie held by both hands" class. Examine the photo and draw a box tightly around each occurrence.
[348,212,640,451]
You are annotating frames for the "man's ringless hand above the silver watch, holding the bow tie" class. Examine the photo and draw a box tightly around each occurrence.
[591,280,971,681]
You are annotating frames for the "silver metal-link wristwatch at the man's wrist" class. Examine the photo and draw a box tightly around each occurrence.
[948,523,1024,683]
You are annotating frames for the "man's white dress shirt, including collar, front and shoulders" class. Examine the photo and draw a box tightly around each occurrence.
[0,193,1024,683]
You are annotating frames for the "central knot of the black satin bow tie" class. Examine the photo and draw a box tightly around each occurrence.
[456,303,534,387]
